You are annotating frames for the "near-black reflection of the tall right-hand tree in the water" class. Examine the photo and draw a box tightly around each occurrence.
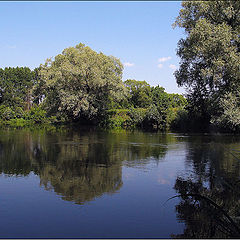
[172,137,240,238]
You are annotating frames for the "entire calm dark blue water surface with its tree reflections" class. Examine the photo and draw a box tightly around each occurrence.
[0,129,240,238]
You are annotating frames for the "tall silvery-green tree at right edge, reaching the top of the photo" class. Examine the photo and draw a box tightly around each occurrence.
[174,0,240,131]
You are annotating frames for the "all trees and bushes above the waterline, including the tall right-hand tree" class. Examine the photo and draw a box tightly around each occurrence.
[0,1,240,133]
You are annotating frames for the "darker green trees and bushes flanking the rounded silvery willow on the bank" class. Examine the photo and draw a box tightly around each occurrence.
[0,64,187,131]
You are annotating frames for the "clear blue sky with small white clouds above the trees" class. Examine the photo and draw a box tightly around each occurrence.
[0,1,184,93]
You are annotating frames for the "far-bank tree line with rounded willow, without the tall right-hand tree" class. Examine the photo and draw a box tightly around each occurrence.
[0,44,186,130]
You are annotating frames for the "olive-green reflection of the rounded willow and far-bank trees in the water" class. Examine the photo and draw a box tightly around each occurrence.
[0,130,170,204]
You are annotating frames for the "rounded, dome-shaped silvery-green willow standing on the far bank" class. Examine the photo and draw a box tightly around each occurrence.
[40,43,125,120]
